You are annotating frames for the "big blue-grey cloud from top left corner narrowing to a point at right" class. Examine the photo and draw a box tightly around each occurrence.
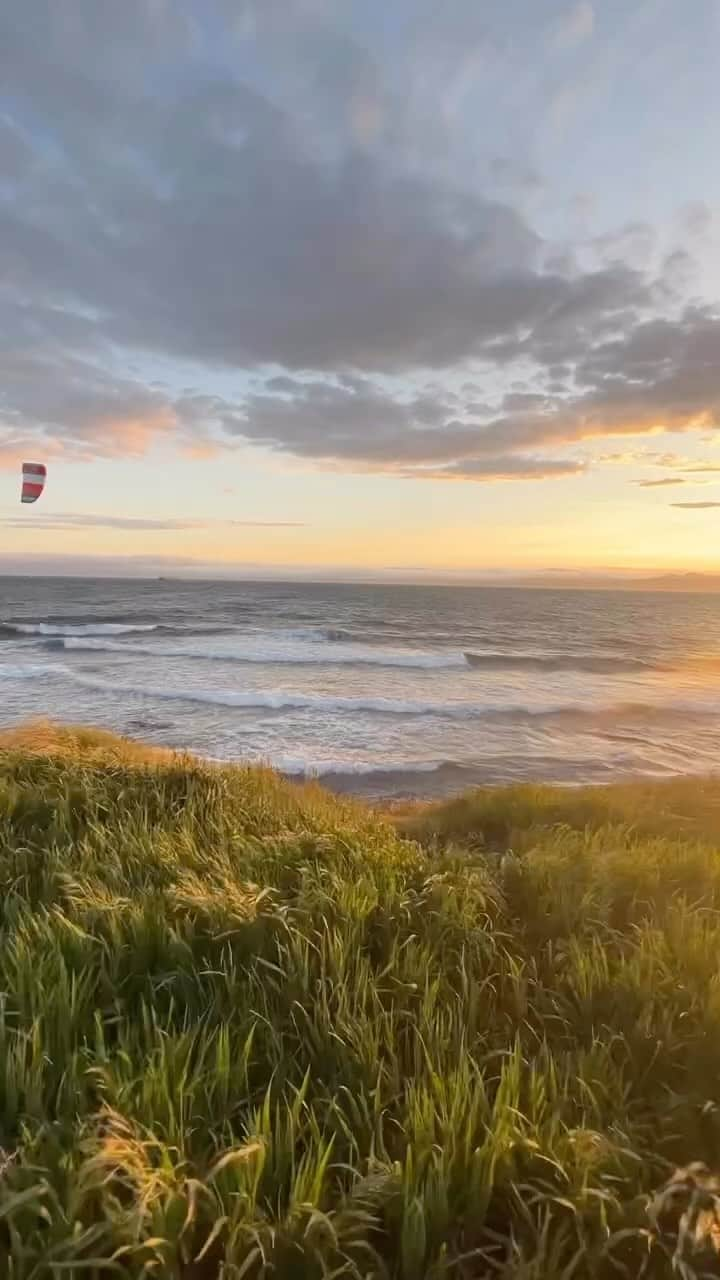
[0,0,647,381]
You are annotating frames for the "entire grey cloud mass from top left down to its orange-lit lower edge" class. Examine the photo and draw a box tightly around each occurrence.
[0,0,720,480]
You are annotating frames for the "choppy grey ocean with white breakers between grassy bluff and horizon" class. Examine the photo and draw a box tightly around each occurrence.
[0,579,720,797]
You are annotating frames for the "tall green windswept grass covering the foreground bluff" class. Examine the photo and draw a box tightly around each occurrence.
[0,726,720,1280]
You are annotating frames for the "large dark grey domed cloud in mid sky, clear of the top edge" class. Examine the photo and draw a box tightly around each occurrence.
[0,97,651,372]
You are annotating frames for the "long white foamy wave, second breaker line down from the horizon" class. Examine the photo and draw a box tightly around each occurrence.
[49,636,466,671]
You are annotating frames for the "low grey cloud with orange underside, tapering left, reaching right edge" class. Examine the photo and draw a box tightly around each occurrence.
[225,307,720,474]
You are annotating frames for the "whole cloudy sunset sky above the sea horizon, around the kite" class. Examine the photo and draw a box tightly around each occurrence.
[0,0,720,577]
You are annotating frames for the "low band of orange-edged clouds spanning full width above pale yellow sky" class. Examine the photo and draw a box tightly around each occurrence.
[0,294,720,479]
